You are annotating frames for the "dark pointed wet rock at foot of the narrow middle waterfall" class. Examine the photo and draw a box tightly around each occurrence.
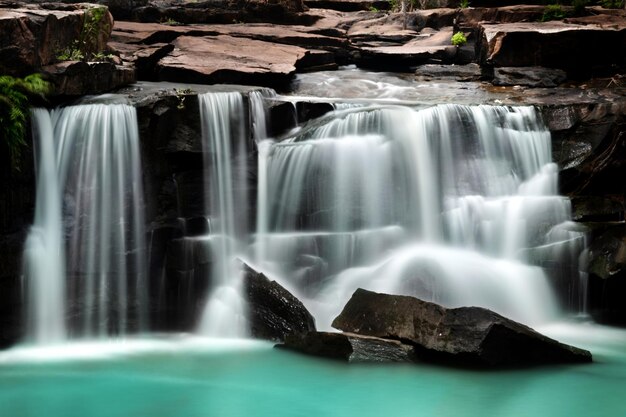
[243,264,315,341]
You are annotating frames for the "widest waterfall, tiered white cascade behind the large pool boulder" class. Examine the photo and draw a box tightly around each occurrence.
[254,105,582,328]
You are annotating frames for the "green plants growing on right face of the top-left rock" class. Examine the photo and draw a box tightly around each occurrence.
[57,7,108,61]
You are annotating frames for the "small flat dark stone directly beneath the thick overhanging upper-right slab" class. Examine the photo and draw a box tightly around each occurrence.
[492,67,567,88]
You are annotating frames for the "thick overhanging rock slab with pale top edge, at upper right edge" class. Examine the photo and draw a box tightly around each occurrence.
[478,19,626,78]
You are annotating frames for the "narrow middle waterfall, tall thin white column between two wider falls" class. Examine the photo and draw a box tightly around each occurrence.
[198,93,251,337]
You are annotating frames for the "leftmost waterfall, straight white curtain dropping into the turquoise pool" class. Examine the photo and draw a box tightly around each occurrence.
[25,104,148,343]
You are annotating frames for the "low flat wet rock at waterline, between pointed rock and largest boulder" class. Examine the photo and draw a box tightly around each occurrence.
[277,332,414,363]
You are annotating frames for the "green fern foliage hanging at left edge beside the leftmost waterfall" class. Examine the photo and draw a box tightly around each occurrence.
[0,74,52,171]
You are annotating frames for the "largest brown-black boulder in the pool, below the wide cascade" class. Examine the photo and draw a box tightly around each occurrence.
[332,289,591,367]
